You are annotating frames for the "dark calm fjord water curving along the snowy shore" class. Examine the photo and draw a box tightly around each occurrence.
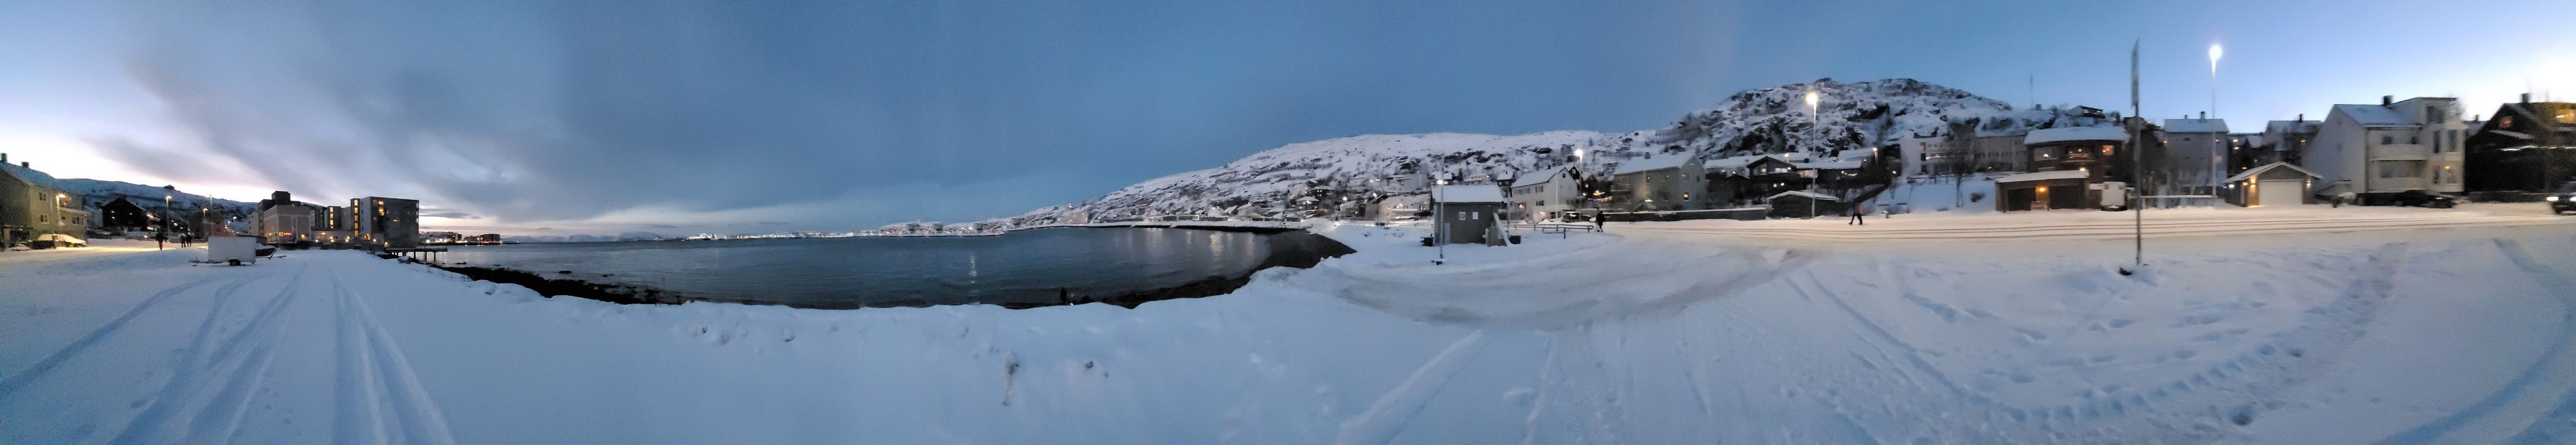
[445,229,1347,309]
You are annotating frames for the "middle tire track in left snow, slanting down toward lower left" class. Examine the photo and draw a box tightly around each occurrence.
[108,265,312,442]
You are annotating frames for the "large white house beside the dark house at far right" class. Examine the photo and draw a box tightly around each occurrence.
[2298,95,2468,203]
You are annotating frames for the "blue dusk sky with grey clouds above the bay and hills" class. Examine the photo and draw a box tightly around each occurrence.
[0,0,2576,234]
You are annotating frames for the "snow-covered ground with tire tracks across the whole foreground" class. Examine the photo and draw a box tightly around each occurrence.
[0,208,2576,442]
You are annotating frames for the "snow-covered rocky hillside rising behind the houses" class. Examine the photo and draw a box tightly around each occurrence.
[1000,79,2099,227]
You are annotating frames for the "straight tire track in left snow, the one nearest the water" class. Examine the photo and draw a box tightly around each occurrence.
[330,275,456,445]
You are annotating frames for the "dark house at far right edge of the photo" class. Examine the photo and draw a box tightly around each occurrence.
[2462,95,2576,198]
